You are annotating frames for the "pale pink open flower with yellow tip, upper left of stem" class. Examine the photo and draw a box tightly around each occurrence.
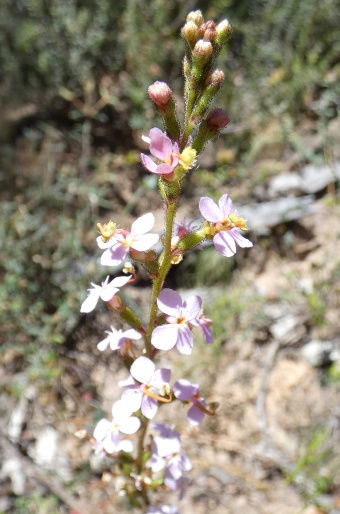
[97,212,159,266]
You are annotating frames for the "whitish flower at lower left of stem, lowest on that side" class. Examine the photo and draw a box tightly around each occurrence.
[93,400,141,453]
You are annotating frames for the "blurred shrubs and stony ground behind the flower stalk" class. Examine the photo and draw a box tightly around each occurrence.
[0,0,340,514]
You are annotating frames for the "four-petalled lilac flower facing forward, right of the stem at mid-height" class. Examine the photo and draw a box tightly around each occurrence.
[151,289,202,355]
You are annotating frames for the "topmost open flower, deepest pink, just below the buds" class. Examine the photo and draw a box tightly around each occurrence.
[140,127,179,175]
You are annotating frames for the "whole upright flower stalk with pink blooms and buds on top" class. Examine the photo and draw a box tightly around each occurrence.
[81,11,252,514]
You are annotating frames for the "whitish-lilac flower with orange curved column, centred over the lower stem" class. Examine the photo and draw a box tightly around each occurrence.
[119,356,171,419]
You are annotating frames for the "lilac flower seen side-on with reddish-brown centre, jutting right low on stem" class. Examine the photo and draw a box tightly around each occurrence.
[174,378,215,426]
